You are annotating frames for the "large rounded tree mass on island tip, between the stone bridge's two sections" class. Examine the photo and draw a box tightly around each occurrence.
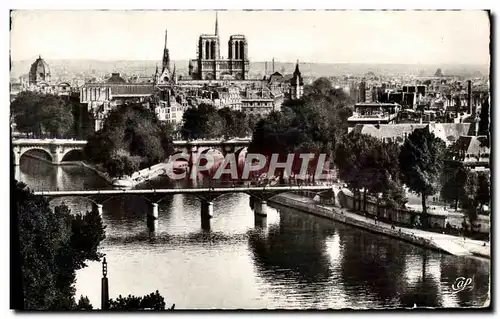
[84,105,173,177]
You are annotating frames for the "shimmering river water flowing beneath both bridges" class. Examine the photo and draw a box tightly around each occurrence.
[15,157,490,309]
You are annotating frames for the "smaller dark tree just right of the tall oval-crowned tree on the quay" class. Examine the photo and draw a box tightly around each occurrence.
[440,161,467,210]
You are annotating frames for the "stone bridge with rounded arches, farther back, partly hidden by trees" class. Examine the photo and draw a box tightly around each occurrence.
[12,138,251,166]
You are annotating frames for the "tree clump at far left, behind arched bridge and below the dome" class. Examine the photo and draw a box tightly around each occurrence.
[11,91,74,138]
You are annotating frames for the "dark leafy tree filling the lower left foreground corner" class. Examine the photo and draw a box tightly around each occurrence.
[14,183,105,310]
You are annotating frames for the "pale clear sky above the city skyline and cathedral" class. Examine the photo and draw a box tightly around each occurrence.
[10,10,490,64]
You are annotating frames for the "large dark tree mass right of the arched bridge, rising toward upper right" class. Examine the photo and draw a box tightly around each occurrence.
[249,78,352,174]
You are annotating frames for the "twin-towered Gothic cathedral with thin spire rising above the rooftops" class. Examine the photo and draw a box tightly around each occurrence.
[189,15,250,80]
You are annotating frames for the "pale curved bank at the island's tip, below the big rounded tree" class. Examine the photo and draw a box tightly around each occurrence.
[80,162,167,188]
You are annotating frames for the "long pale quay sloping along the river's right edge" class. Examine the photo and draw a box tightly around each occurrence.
[269,193,491,259]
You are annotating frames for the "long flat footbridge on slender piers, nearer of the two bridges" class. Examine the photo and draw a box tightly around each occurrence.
[34,185,334,232]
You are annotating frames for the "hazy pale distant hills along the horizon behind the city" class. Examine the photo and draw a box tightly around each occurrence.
[11,59,489,82]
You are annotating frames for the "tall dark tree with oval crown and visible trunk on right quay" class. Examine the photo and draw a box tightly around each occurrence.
[399,128,445,227]
